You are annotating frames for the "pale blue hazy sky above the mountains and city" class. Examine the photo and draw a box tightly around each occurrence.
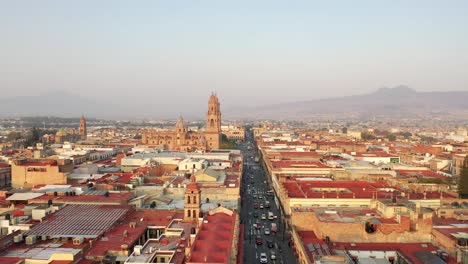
[0,0,468,112]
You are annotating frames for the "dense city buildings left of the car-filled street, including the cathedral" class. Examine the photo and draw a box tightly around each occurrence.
[0,94,249,264]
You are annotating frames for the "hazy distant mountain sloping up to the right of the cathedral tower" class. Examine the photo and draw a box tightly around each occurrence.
[230,86,468,119]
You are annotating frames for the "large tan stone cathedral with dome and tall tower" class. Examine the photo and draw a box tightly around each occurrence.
[141,94,221,151]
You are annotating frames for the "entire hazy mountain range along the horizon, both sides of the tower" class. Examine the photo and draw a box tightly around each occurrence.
[0,86,468,119]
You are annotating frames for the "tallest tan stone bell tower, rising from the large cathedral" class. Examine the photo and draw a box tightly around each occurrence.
[205,93,221,149]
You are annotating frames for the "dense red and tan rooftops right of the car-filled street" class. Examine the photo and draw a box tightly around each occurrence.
[253,122,468,264]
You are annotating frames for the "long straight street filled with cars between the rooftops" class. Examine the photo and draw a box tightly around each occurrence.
[239,133,296,264]
